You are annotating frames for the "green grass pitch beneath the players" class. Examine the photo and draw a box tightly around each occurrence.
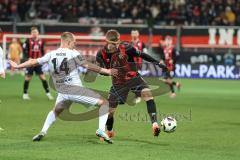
[0,76,240,160]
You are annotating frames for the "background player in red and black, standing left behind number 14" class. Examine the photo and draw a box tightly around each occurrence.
[23,27,53,100]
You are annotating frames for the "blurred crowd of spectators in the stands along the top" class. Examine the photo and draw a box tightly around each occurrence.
[0,0,240,25]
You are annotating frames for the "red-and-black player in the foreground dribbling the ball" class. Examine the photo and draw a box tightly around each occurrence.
[96,30,165,137]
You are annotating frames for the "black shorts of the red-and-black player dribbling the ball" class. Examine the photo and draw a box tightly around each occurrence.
[108,76,149,108]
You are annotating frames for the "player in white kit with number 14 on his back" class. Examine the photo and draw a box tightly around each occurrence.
[10,32,117,143]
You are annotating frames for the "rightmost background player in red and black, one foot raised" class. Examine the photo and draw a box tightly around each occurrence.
[160,36,181,98]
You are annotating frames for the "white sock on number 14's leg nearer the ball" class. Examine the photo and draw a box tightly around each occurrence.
[99,103,109,131]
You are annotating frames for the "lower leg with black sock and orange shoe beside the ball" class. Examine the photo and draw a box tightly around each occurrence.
[141,88,160,136]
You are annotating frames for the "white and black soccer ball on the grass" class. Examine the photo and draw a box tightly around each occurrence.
[161,117,177,133]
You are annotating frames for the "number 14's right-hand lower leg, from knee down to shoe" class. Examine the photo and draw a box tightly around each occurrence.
[96,99,113,143]
